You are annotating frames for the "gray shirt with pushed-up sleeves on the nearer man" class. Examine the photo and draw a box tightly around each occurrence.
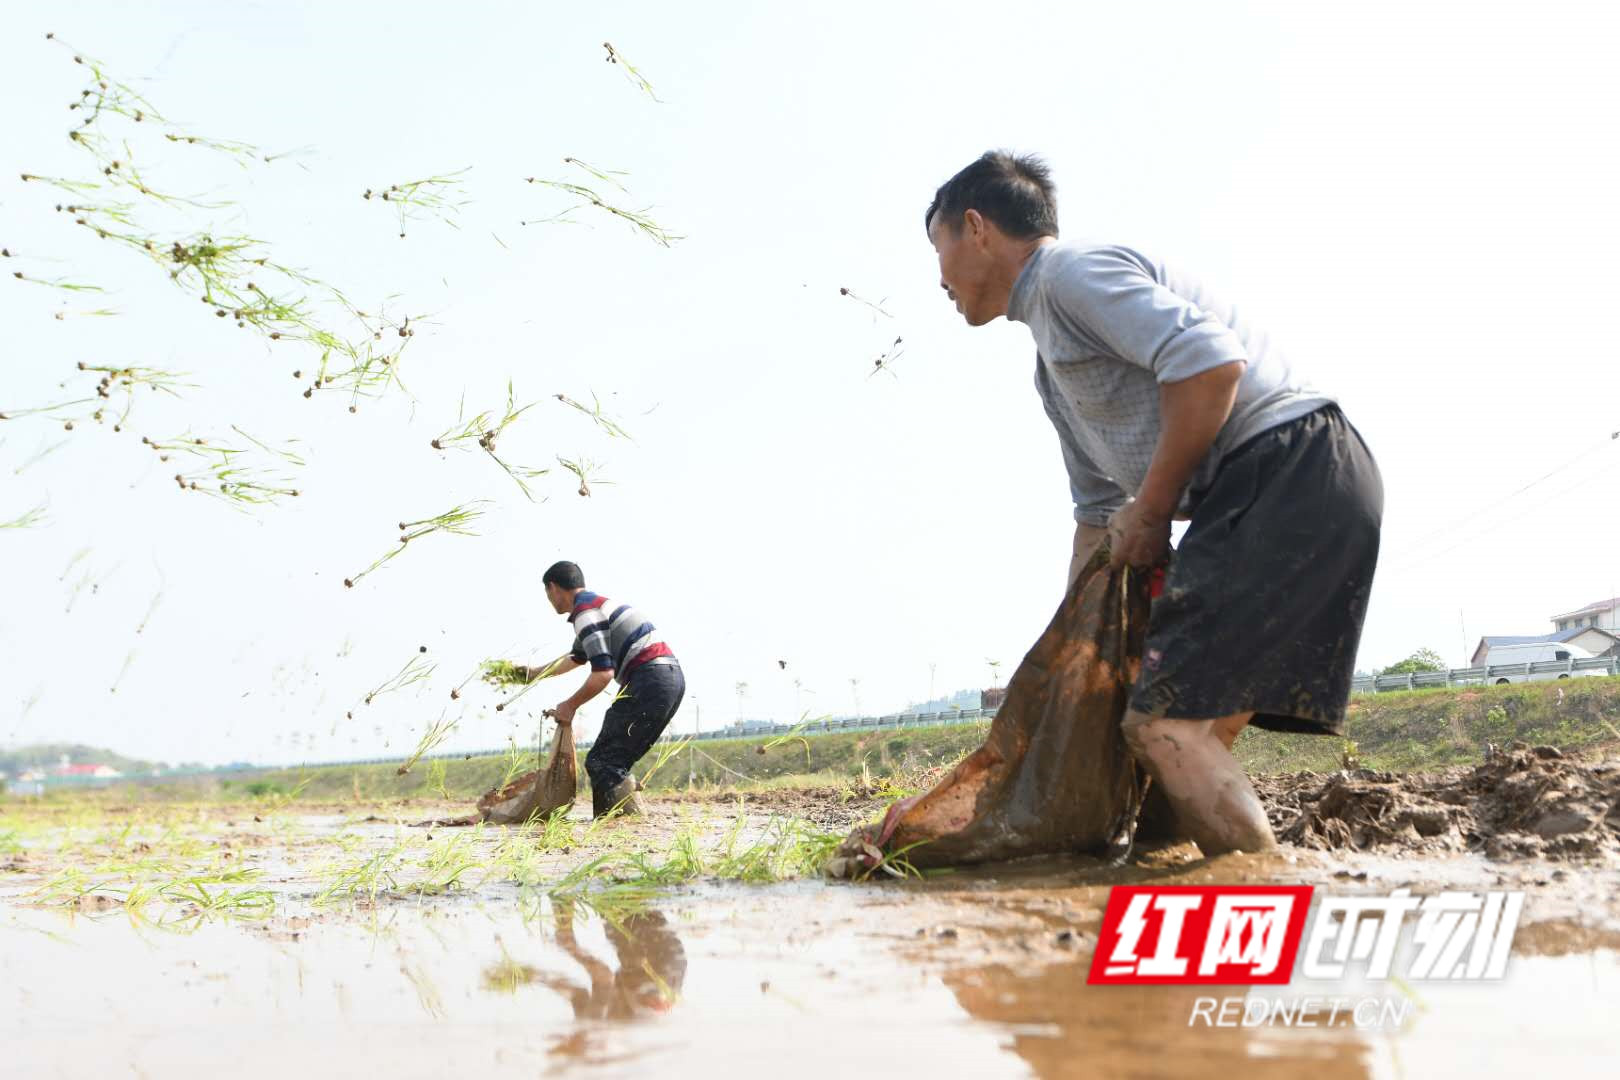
[1008,241,1333,526]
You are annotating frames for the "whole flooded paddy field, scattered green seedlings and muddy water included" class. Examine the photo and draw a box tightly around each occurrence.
[0,773,1620,1078]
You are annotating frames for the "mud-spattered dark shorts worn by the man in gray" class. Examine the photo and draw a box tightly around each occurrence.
[1131,405,1383,735]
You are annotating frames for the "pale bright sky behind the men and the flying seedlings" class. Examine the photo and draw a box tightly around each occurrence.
[0,0,1620,773]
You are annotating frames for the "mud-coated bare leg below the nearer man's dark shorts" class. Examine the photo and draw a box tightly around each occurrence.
[1124,711,1277,855]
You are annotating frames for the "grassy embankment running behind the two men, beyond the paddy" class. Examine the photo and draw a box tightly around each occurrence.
[25,678,1620,801]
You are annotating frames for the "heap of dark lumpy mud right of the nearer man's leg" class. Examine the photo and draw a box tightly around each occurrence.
[1256,743,1620,866]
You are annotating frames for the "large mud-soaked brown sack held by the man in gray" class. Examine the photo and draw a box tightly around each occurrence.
[826,551,1149,878]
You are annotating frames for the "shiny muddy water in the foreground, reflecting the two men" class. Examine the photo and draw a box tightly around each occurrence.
[0,826,1620,1080]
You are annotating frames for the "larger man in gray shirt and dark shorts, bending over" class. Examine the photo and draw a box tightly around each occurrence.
[927,152,1383,855]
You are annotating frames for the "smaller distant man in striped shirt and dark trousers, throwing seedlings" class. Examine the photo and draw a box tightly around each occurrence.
[518,562,687,818]
